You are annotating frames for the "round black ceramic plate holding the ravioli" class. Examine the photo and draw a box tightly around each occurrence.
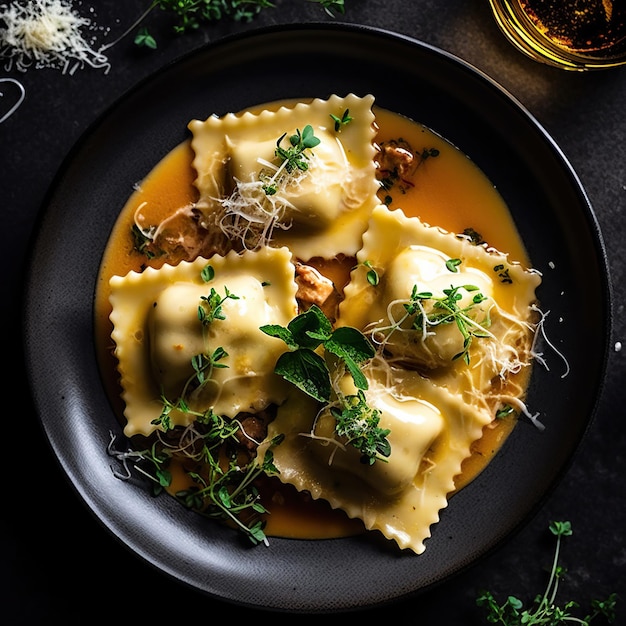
[25,24,610,612]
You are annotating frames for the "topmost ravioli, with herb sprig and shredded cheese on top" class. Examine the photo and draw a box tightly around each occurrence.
[188,94,379,260]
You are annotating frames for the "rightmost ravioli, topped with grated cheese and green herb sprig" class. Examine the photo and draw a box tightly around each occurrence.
[338,205,541,402]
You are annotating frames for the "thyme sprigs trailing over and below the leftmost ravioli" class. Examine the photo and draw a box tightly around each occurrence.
[135,264,282,544]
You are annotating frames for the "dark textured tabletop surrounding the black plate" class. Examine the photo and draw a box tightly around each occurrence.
[0,0,626,626]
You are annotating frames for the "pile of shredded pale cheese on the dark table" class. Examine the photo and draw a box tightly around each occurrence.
[0,0,110,74]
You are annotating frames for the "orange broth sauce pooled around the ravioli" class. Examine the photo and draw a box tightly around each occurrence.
[95,103,530,539]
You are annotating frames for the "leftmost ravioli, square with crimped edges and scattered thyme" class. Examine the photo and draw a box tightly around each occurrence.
[110,247,297,436]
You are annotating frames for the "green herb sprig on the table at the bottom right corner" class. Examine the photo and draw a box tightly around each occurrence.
[476,522,617,626]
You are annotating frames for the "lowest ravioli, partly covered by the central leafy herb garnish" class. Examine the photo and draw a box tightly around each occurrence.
[258,364,491,554]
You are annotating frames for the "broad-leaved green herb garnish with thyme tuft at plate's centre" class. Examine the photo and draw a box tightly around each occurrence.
[261,305,391,465]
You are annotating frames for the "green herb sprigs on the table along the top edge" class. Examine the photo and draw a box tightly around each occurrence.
[133,0,345,49]
